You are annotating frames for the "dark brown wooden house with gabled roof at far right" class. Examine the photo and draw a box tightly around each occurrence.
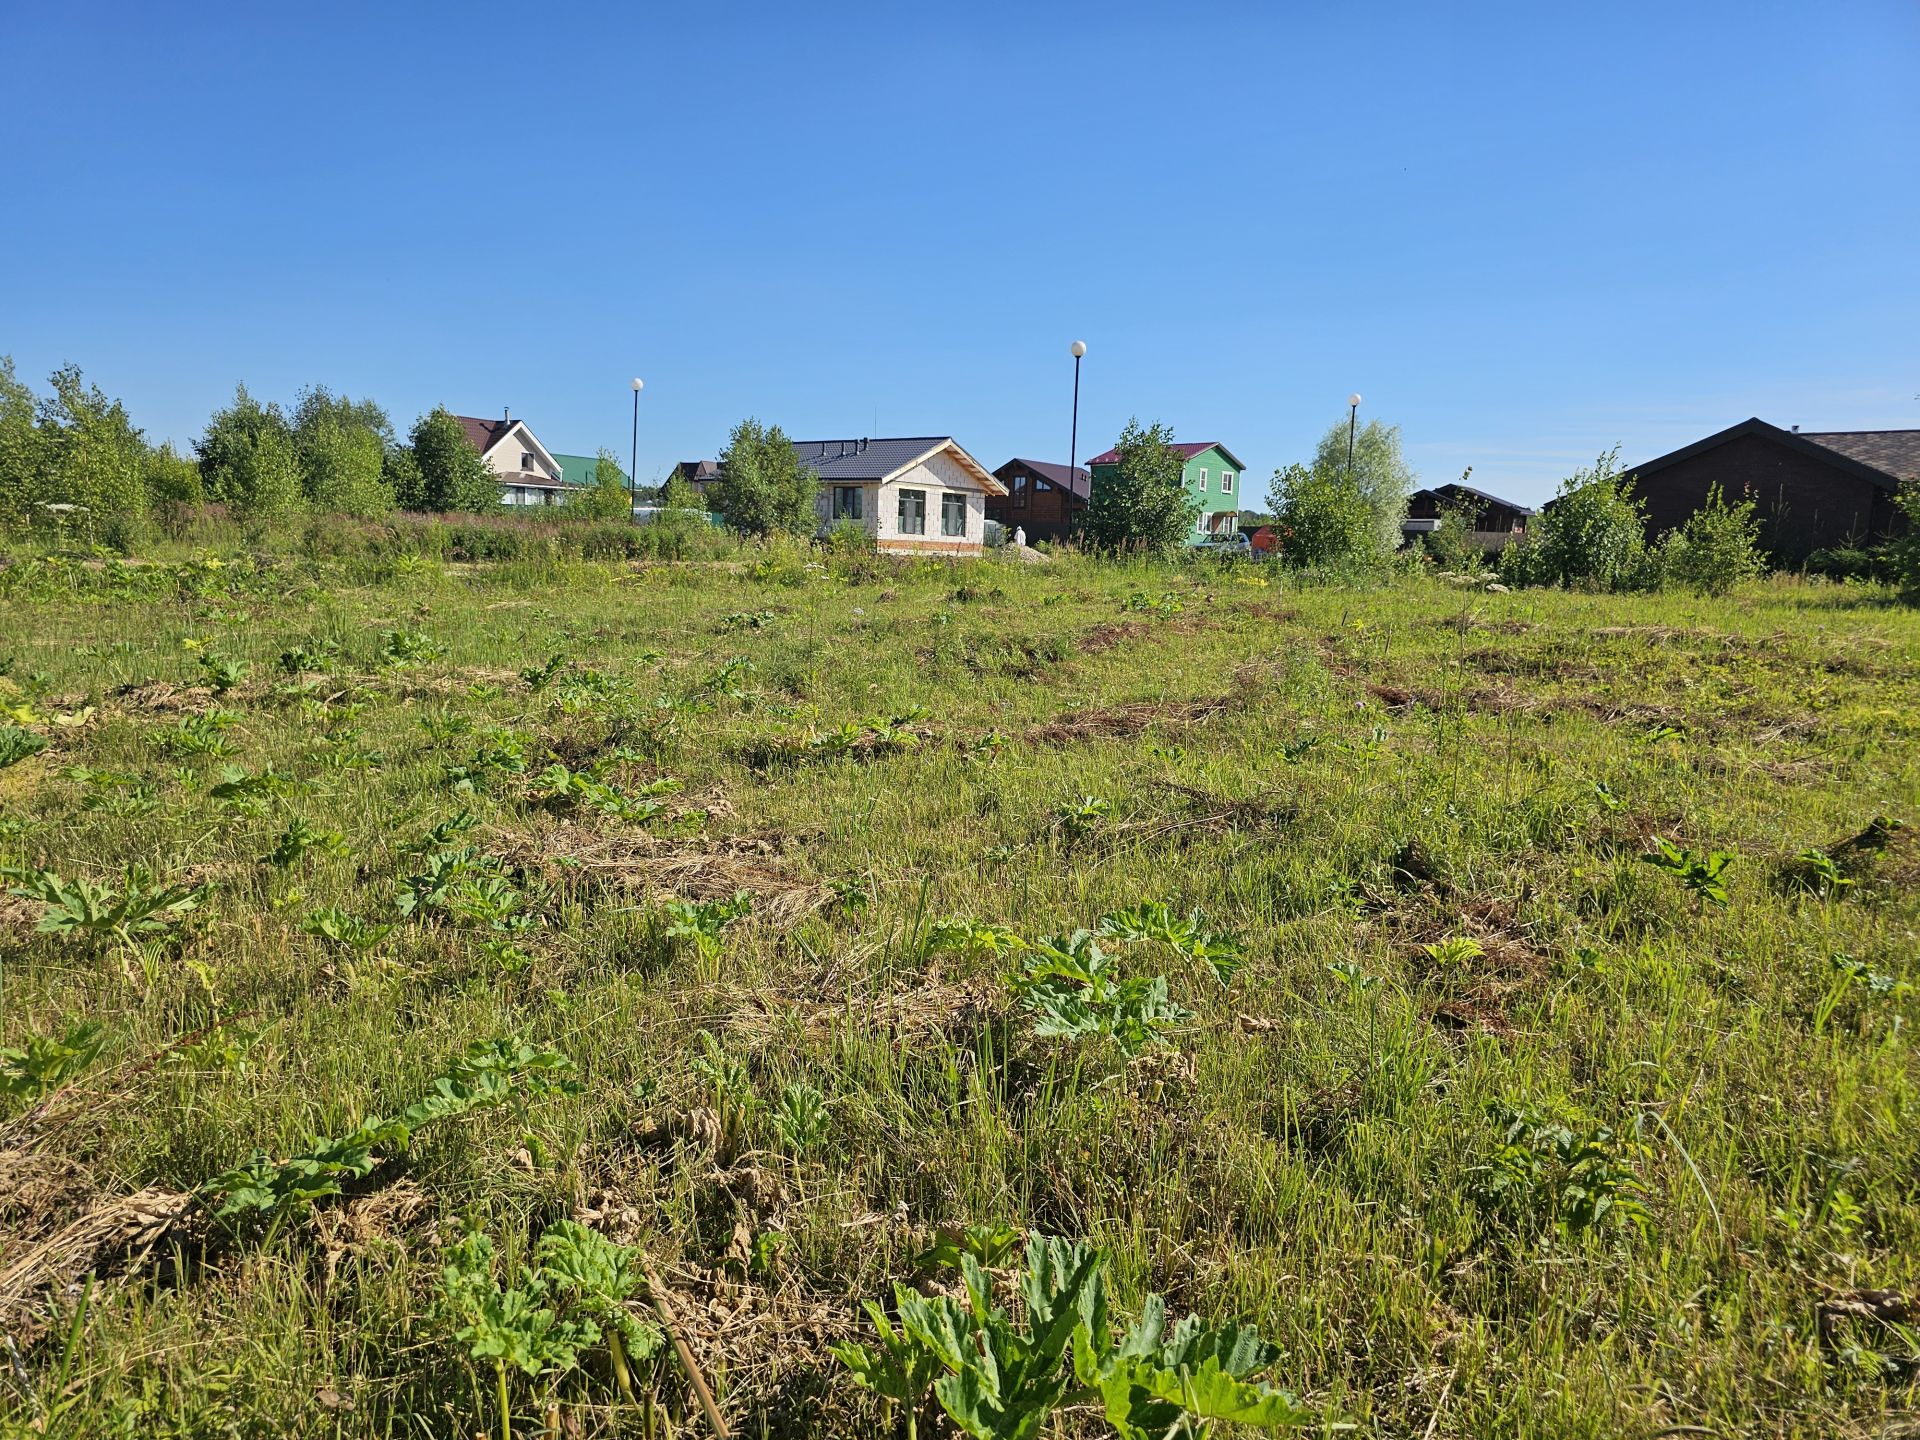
[1628,419,1920,563]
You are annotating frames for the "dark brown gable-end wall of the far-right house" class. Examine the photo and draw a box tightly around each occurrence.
[1634,434,1897,563]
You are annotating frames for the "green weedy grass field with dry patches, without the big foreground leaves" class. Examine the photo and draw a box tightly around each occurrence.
[0,551,1920,1438]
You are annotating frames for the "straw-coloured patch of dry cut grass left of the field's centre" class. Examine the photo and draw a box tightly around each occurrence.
[497,822,833,925]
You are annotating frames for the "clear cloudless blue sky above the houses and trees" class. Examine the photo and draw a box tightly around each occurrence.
[0,0,1920,499]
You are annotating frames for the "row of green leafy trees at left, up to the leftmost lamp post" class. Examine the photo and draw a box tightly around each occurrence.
[0,357,632,549]
